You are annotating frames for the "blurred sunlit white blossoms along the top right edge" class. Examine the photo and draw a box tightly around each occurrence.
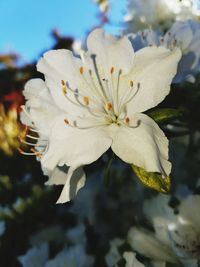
[125,0,200,32]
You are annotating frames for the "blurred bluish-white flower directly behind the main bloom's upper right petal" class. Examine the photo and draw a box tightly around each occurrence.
[129,20,200,83]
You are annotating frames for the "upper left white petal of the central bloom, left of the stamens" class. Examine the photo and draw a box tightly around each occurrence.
[37,49,86,114]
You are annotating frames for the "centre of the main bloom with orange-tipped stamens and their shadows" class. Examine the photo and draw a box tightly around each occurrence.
[61,55,140,128]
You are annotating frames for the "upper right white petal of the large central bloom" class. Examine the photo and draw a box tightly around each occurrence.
[125,47,181,114]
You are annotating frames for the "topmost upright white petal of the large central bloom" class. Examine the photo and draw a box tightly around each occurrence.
[87,29,134,73]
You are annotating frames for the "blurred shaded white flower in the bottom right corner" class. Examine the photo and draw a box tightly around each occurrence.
[128,195,200,267]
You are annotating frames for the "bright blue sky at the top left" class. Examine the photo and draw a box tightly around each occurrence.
[0,0,126,62]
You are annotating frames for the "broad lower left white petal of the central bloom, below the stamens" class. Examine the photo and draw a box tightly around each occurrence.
[41,116,112,170]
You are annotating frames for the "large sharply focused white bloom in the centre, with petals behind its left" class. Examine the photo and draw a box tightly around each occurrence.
[22,29,181,203]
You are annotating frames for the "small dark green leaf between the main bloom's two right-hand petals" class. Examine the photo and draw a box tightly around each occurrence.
[148,108,183,123]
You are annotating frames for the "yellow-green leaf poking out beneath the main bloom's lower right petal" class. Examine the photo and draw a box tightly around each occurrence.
[131,165,171,193]
